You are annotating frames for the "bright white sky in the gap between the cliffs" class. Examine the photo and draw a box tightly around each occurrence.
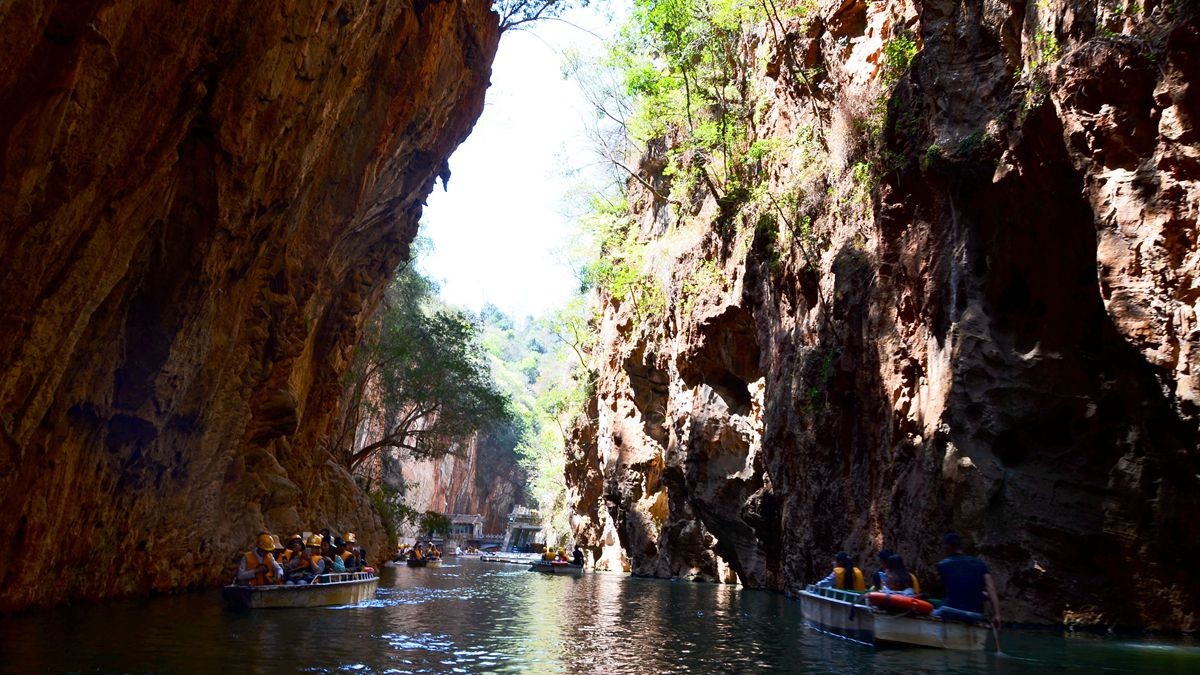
[420,11,614,318]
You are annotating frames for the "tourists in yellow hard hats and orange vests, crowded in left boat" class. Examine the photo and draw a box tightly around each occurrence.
[234,528,370,586]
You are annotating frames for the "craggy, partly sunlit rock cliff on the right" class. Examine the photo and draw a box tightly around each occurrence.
[568,0,1200,629]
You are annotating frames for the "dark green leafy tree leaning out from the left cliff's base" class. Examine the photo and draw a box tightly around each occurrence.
[332,265,515,471]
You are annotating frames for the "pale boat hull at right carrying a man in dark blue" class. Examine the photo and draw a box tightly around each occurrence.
[800,586,988,650]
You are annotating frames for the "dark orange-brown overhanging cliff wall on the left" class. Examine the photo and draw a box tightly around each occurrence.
[0,0,498,610]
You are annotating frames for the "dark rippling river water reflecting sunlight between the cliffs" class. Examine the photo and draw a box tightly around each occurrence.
[0,560,1200,673]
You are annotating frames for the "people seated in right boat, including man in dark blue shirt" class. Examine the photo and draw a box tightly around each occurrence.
[816,532,1000,627]
